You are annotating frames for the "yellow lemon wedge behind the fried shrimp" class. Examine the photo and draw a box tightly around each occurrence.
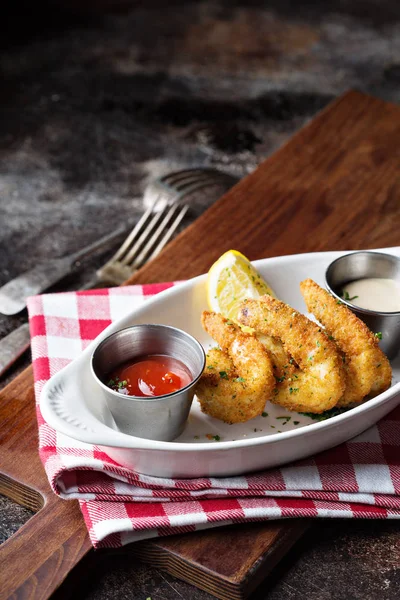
[207,250,276,321]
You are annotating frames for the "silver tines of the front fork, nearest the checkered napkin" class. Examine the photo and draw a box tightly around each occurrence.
[97,195,189,285]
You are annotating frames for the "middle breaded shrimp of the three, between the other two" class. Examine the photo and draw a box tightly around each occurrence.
[238,296,345,413]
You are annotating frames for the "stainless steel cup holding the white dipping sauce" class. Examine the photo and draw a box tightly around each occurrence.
[325,251,400,358]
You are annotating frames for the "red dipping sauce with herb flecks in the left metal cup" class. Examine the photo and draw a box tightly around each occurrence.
[105,354,193,396]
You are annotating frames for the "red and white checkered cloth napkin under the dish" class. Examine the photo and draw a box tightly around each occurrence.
[28,283,400,547]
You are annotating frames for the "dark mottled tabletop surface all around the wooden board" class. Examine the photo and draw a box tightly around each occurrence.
[0,0,400,600]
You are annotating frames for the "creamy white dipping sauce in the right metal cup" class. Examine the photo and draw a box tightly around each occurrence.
[343,277,400,312]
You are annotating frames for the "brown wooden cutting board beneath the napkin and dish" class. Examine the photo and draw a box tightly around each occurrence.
[0,92,400,599]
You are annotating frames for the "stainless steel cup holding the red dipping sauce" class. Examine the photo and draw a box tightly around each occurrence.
[91,325,206,441]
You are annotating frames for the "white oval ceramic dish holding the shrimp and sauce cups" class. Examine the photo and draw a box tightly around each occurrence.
[40,247,400,478]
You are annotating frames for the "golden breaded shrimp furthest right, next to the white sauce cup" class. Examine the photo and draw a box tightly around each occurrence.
[300,279,392,406]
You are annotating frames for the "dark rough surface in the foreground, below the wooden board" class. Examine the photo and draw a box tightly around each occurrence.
[50,519,400,600]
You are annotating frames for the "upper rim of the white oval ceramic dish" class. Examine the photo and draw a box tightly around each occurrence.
[39,246,400,452]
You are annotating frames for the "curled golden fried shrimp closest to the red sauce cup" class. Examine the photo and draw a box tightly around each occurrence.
[196,311,275,423]
